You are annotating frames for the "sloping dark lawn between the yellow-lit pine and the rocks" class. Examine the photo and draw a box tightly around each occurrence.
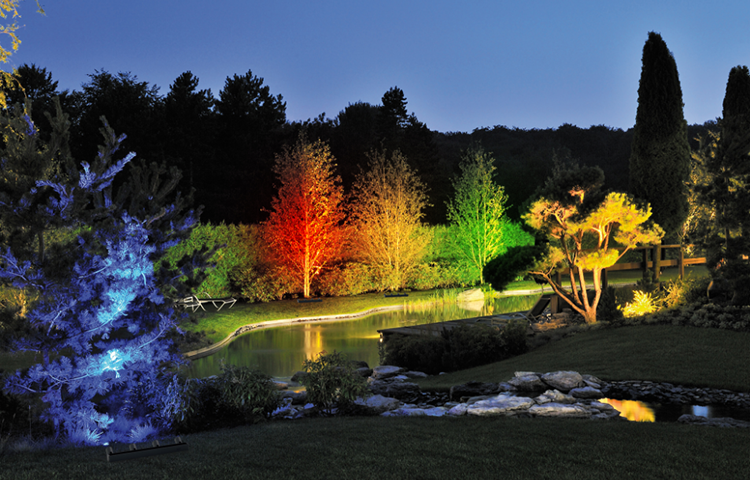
[419,325,750,392]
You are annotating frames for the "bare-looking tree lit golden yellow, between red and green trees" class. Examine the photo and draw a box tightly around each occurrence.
[351,151,431,290]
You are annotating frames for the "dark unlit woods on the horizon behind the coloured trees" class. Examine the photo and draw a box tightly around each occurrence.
[8,65,712,225]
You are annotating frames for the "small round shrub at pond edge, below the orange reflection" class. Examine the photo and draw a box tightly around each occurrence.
[302,351,368,413]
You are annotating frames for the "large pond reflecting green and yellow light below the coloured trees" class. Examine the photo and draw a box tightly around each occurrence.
[188,295,539,378]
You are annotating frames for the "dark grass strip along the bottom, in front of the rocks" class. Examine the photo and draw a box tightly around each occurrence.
[0,417,750,480]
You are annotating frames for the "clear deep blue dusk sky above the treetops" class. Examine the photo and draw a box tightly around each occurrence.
[6,0,750,132]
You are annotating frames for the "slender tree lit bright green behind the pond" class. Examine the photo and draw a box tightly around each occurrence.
[448,147,507,283]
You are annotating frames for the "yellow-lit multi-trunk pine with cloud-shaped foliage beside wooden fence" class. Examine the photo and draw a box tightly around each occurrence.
[524,165,664,323]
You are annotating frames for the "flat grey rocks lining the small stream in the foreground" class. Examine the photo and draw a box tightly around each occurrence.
[274,366,750,426]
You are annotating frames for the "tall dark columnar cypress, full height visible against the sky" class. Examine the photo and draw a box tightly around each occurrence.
[630,32,690,239]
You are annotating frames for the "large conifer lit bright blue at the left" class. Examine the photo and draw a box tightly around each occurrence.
[0,104,201,444]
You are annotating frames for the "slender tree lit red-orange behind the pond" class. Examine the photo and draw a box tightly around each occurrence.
[263,136,345,297]
